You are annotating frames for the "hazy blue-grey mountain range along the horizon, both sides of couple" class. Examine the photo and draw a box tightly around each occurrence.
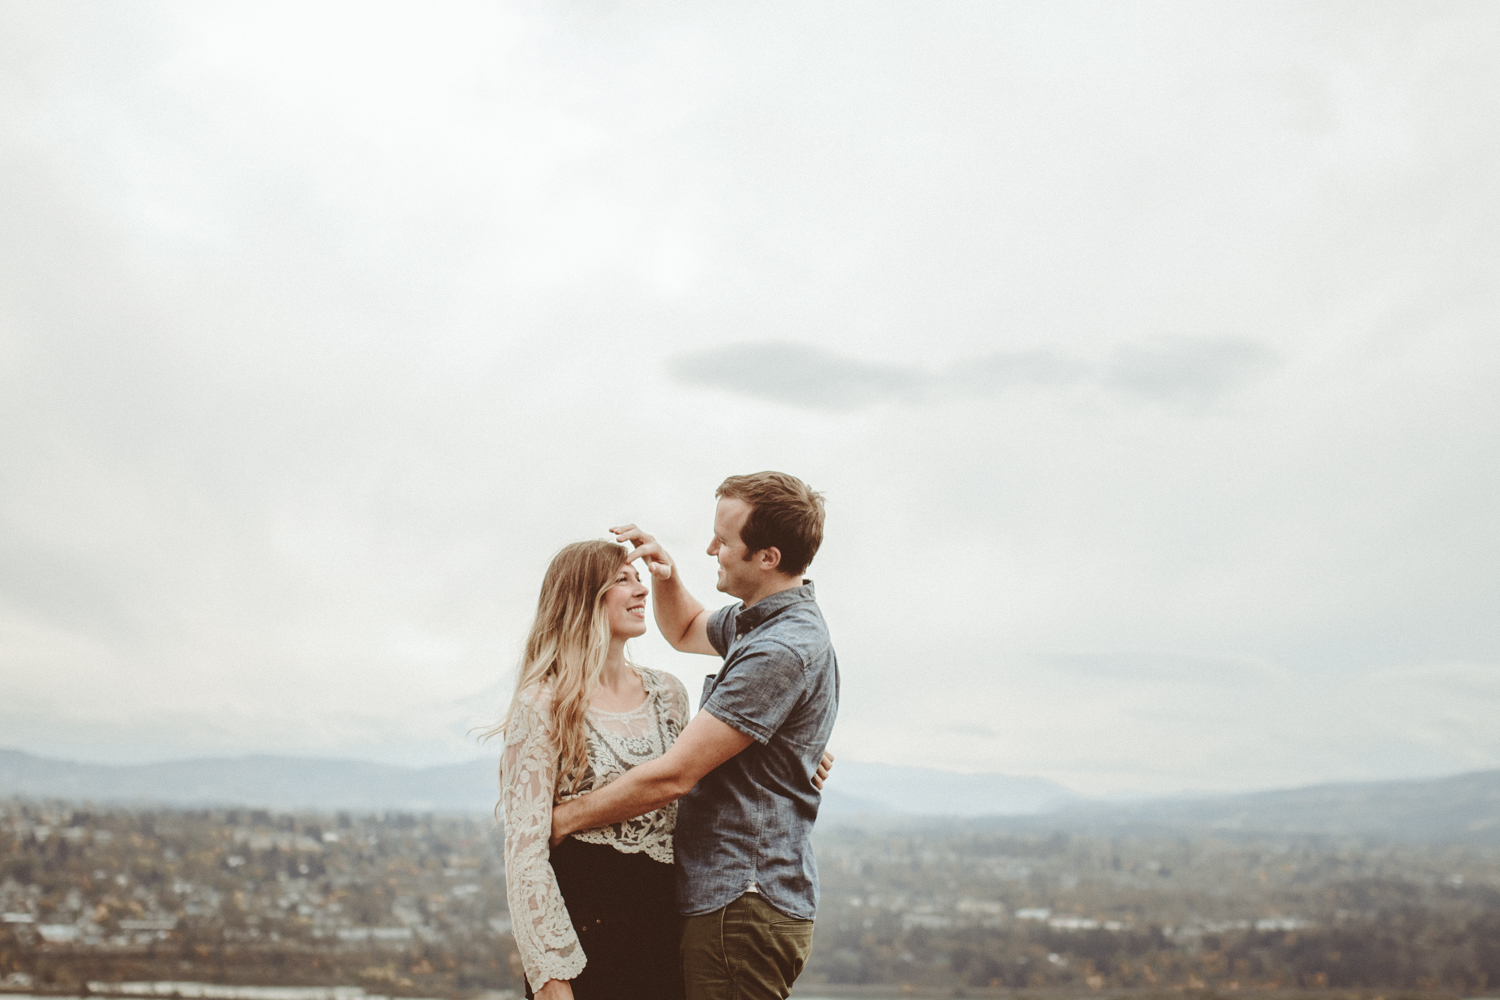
[0,750,1500,844]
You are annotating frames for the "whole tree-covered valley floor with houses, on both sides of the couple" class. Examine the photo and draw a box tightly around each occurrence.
[0,802,1500,997]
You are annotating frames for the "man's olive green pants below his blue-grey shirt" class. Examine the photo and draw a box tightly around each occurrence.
[683,892,813,1000]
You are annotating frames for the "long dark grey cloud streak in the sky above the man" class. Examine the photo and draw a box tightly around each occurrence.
[669,336,1278,411]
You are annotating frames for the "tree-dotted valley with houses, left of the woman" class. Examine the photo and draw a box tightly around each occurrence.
[0,804,519,996]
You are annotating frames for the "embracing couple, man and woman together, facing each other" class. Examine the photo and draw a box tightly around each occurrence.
[495,472,839,1000]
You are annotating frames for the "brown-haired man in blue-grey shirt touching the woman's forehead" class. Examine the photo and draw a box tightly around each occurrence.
[552,472,839,1000]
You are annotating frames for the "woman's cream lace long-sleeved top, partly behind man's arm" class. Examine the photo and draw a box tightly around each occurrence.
[500,667,687,990]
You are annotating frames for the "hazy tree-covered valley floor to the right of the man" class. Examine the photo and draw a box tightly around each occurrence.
[807,828,1500,996]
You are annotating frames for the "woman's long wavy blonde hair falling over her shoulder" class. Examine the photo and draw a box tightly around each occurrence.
[483,541,629,792]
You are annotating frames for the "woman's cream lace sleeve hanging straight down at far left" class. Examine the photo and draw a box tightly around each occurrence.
[501,694,587,990]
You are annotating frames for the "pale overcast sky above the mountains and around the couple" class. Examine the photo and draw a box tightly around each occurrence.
[0,0,1500,793]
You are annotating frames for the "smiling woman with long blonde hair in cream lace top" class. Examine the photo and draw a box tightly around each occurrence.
[491,541,687,1000]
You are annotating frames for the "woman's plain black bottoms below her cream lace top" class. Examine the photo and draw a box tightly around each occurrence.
[527,837,686,1000]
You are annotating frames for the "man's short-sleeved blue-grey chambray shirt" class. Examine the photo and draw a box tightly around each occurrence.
[674,580,839,921]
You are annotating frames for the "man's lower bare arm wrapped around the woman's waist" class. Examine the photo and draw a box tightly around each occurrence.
[552,704,752,844]
